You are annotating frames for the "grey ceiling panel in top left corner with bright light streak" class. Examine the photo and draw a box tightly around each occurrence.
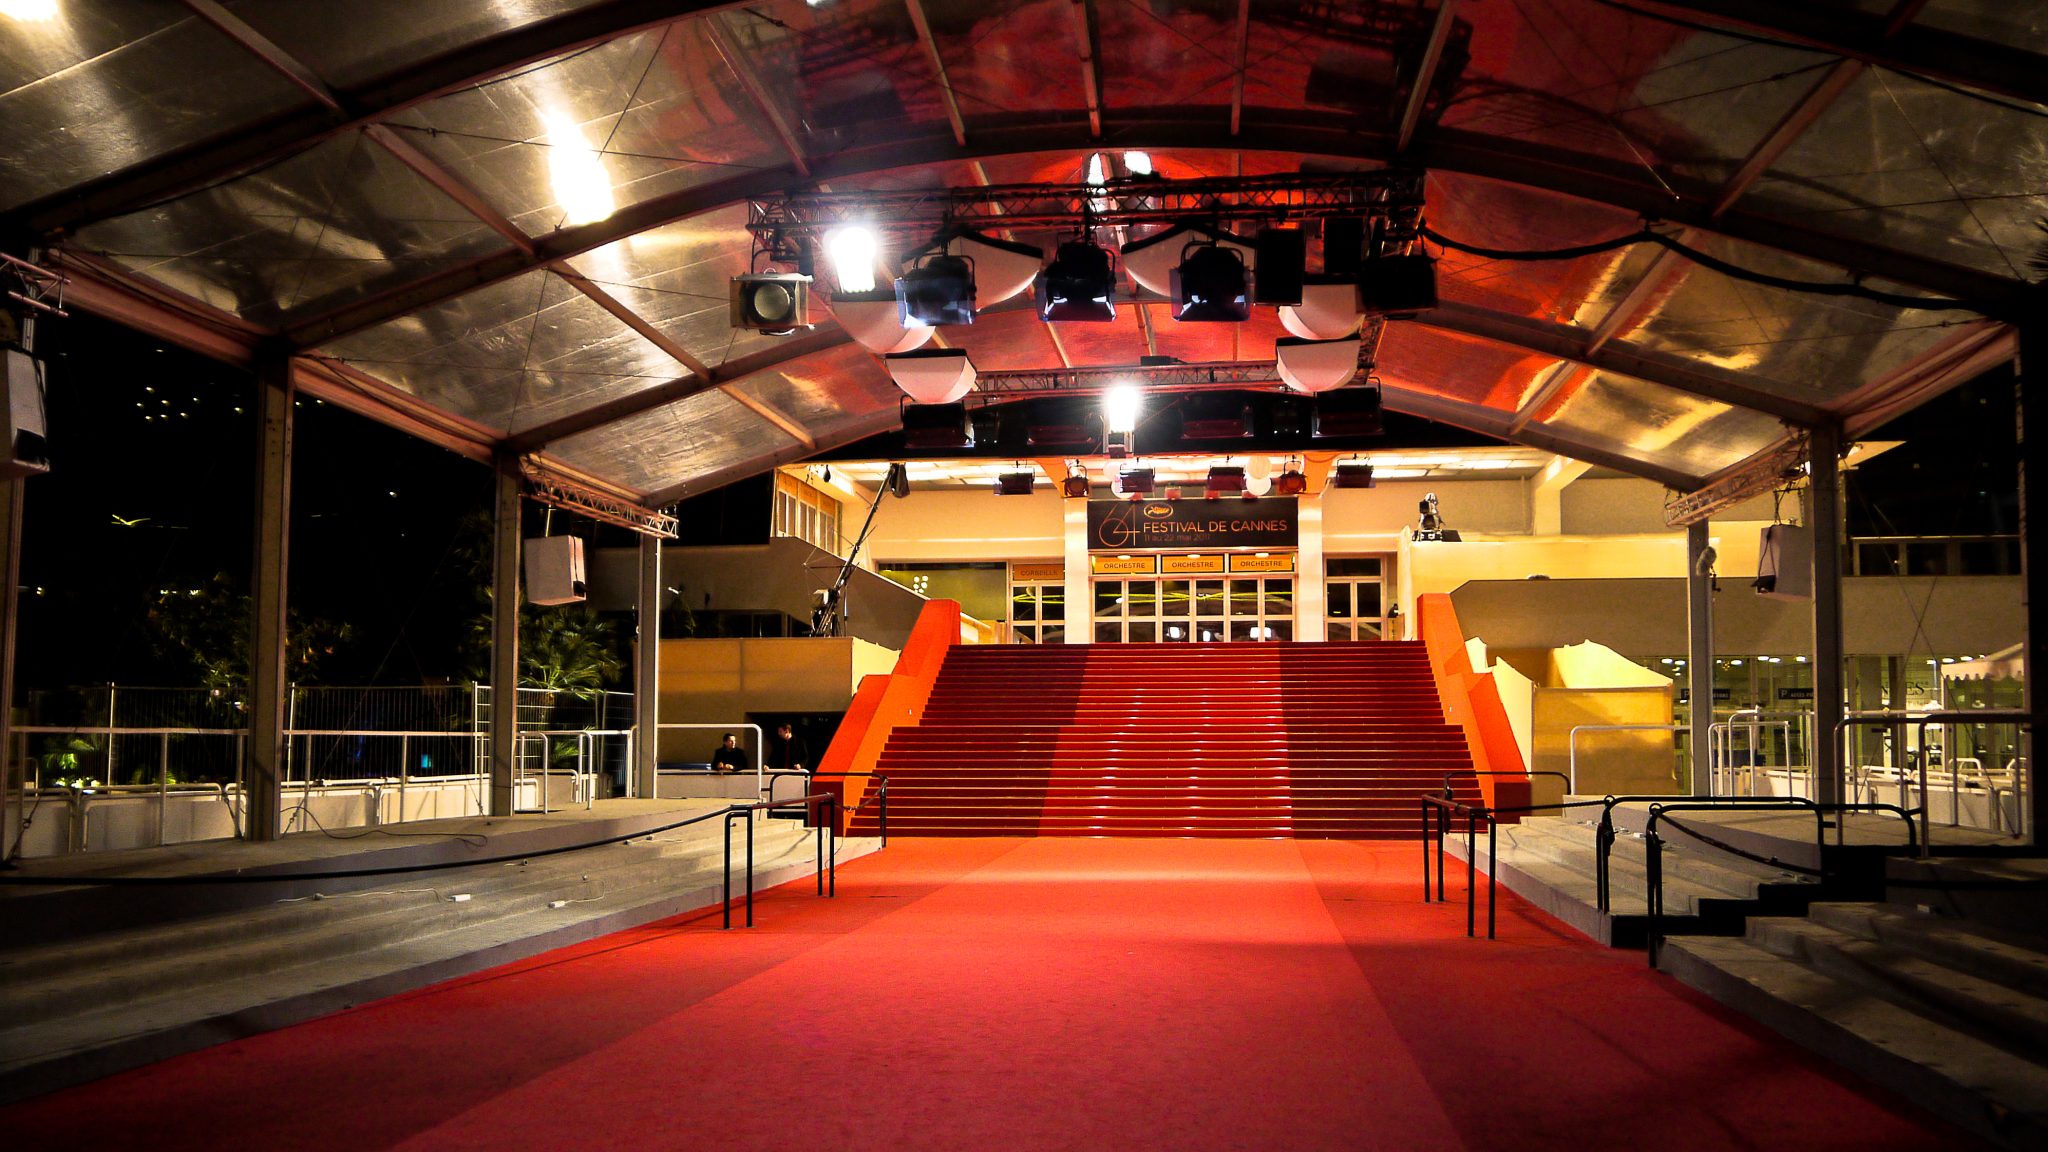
[0,0,311,209]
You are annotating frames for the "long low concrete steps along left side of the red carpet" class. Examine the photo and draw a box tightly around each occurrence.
[0,824,877,1101]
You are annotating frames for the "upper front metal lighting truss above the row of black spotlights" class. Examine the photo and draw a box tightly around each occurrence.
[748,168,1425,254]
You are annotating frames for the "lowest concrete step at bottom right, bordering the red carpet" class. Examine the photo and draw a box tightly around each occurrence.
[1659,937,2048,1150]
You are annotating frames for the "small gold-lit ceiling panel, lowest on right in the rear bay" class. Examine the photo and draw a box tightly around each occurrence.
[1538,371,1786,478]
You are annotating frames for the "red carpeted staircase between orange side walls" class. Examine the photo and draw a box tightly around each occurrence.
[852,642,1479,838]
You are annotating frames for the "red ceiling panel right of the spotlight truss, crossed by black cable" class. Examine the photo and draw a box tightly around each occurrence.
[1427,172,1640,326]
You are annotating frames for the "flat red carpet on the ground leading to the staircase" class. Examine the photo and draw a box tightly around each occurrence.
[0,838,1972,1152]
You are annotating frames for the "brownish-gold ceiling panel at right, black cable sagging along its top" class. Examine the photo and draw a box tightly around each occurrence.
[1620,236,1970,404]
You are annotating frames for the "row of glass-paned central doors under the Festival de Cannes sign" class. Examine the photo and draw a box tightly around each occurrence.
[1094,576,1294,644]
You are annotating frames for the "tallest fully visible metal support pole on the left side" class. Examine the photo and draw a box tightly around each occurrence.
[242,357,295,840]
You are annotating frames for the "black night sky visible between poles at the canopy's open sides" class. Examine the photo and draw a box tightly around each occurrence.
[16,314,2017,691]
